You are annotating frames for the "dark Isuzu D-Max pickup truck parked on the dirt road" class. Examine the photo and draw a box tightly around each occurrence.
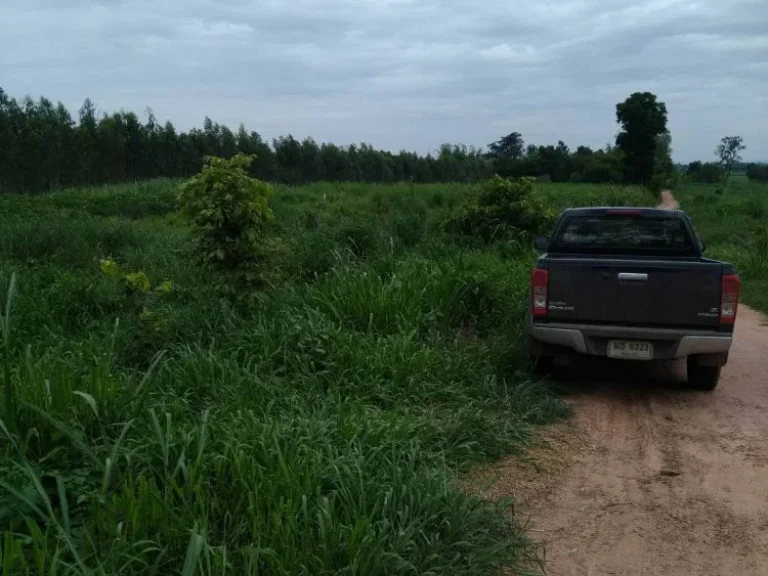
[528,208,740,390]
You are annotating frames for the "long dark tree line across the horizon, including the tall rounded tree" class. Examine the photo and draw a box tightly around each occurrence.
[0,88,760,193]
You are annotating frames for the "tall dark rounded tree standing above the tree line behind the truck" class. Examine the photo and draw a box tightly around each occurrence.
[616,92,667,184]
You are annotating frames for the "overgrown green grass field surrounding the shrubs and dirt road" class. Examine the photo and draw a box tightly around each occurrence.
[0,181,766,575]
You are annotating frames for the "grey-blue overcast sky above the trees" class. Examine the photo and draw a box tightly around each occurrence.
[0,0,768,161]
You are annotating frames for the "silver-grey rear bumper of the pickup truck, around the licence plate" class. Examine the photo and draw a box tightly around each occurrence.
[530,323,733,359]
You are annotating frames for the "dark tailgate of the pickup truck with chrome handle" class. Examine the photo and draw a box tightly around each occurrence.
[548,257,722,329]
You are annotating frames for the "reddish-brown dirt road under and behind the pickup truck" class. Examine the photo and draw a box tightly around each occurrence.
[474,197,768,576]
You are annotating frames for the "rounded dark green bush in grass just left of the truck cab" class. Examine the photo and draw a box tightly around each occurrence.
[446,176,550,243]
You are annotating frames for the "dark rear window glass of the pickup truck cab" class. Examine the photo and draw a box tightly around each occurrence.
[550,216,696,256]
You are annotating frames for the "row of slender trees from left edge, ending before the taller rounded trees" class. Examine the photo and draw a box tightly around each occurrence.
[0,88,493,192]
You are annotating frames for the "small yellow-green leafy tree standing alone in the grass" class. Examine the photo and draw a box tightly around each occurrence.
[179,154,274,299]
